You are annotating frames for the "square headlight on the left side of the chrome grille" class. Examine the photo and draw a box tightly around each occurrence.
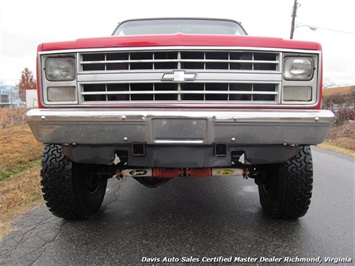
[45,57,76,81]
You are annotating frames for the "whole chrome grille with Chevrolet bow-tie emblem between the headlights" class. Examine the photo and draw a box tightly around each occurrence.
[78,48,282,104]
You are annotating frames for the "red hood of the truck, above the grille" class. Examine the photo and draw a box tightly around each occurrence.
[38,33,321,51]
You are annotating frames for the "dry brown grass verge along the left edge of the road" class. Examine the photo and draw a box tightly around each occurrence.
[0,109,43,237]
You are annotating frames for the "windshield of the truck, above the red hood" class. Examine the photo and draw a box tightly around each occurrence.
[113,19,246,36]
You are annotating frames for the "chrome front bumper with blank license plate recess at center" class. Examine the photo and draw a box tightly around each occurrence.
[27,108,334,145]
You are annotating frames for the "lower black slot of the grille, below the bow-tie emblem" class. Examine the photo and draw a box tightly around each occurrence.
[81,83,278,103]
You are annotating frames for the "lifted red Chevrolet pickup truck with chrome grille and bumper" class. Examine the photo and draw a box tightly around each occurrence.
[27,18,334,219]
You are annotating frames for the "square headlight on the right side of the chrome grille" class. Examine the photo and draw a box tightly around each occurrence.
[283,57,314,80]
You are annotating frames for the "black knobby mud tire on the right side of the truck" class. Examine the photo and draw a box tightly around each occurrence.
[259,146,313,220]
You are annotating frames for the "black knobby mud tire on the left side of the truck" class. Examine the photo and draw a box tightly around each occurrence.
[41,144,107,220]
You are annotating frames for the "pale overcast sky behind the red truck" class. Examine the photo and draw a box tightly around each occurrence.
[0,0,355,85]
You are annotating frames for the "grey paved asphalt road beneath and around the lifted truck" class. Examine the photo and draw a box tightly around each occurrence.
[0,148,355,266]
